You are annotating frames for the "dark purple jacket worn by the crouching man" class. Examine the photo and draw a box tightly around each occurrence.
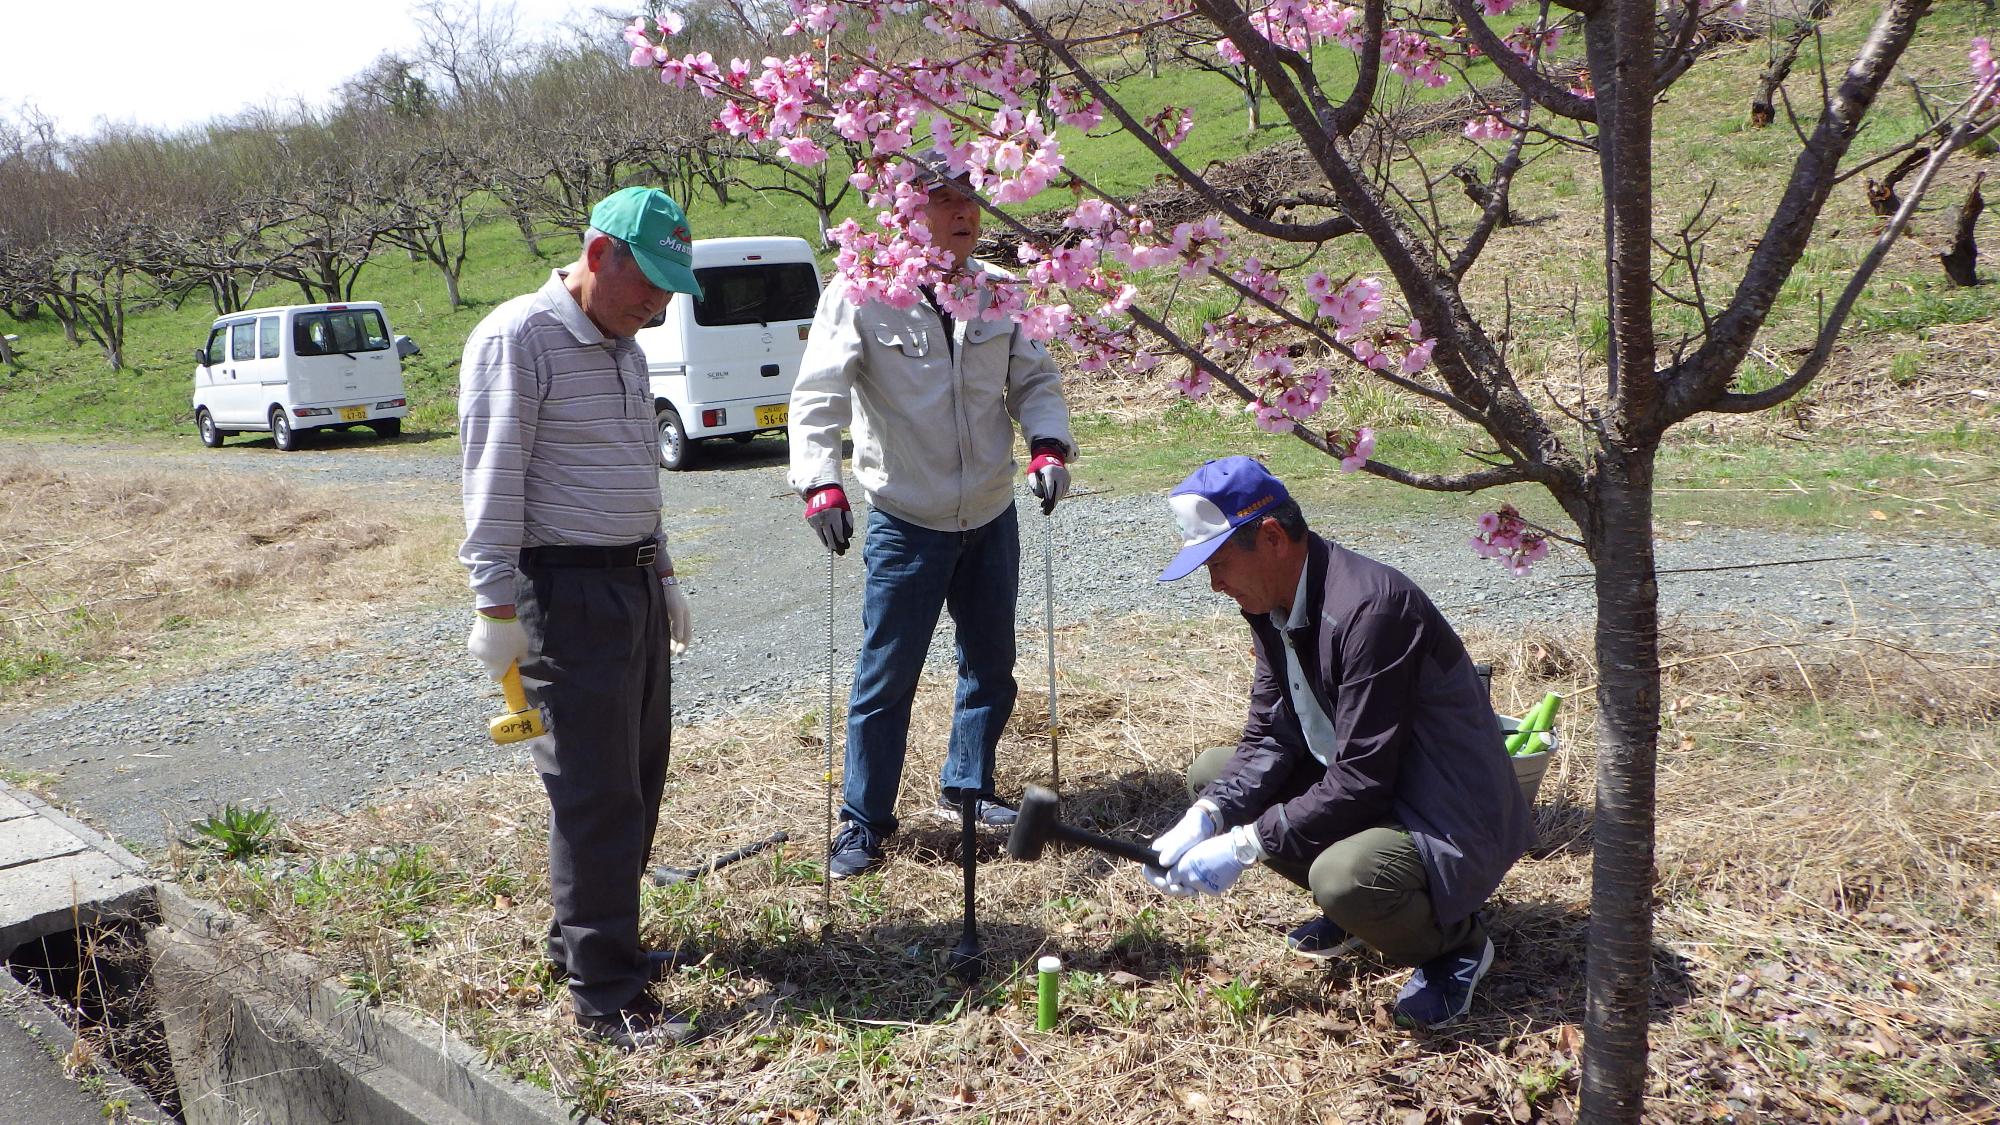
[1202,534,1534,925]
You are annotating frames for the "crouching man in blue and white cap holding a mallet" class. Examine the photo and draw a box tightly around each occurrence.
[1146,456,1534,1027]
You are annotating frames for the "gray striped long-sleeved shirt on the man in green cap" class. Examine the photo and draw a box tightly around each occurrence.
[458,270,674,607]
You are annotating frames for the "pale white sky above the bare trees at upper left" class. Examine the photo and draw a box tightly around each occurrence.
[0,0,638,136]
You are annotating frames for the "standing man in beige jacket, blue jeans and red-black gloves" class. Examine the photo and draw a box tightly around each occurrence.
[790,150,1076,879]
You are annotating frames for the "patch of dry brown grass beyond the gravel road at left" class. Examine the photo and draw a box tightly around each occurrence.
[0,458,452,695]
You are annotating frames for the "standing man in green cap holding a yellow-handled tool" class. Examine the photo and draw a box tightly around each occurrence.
[458,188,702,1049]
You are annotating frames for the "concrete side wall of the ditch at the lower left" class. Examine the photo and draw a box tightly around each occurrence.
[146,885,604,1125]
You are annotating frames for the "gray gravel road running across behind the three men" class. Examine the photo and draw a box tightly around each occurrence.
[0,436,2000,849]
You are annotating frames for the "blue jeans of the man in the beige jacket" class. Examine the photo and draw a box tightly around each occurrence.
[840,504,1020,835]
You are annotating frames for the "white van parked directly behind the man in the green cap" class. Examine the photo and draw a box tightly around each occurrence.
[638,238,820,468]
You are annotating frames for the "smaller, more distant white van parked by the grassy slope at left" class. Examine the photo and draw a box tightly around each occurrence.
[194,300,410,450]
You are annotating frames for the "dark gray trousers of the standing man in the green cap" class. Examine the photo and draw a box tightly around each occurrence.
[516,563,672,1015]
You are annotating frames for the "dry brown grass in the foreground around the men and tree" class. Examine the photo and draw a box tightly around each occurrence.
[184,619,2000,1125]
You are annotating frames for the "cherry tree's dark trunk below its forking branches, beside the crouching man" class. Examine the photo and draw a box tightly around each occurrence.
[1582,448,1660,1125]
